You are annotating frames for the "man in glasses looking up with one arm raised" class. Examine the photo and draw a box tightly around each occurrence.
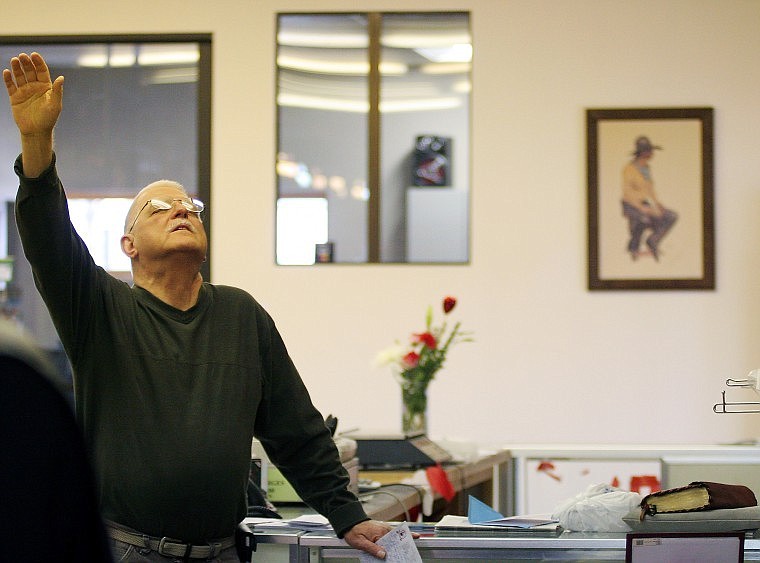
[3,53,390,561]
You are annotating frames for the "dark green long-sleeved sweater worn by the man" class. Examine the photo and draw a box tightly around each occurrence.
[16,154,367,543]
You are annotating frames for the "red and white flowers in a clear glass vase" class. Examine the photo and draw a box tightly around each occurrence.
[377,297,472,435]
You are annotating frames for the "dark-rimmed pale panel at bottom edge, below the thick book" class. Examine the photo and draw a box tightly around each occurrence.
[625,532,744,563]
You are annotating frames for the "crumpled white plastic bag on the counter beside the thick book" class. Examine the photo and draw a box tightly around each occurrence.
[552,483,641,532]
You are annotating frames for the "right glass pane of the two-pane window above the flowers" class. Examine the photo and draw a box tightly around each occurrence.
[380,13,472,263]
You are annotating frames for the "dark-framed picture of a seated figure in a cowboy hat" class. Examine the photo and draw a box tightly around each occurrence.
[586,108,715,290]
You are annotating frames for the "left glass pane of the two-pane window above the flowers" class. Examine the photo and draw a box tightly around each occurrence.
[277,14,369,264]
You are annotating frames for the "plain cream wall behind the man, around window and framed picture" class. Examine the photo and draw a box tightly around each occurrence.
[5,0,760,450]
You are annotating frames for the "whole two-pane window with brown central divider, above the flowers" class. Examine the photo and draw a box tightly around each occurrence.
[276,12,472,264]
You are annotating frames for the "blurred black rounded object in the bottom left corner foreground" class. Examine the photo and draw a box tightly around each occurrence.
[0,319,113,563]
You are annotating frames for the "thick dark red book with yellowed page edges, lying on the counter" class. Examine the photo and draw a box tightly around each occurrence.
[641,481,757,518]
